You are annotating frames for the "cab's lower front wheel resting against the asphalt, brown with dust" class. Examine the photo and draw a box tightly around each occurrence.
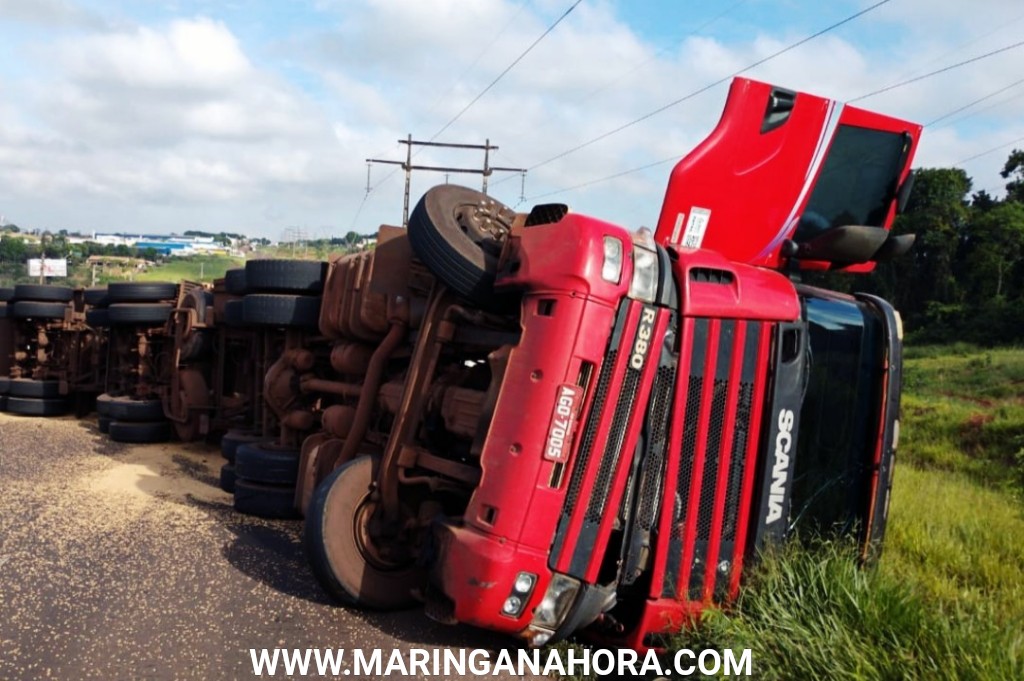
[304,456,422,610]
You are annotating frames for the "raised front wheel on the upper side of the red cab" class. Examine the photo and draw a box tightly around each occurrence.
[409,184,515,305]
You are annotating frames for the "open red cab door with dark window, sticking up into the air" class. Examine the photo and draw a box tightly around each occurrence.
[655,78,921,271]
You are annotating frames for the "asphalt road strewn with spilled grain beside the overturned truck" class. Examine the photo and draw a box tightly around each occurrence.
[0,414,544,680]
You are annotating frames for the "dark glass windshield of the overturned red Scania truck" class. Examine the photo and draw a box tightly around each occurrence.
[791,291,886,536]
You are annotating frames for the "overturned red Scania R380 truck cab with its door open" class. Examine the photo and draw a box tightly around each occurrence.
[297,79,921,648]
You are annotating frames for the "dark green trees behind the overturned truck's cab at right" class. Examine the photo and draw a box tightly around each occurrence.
[807,150,1024,345]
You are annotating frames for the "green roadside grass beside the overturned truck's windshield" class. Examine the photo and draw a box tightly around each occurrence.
[677,345,1024,679]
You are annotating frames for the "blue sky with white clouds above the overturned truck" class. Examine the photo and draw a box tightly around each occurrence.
[0,0,1024,240]
